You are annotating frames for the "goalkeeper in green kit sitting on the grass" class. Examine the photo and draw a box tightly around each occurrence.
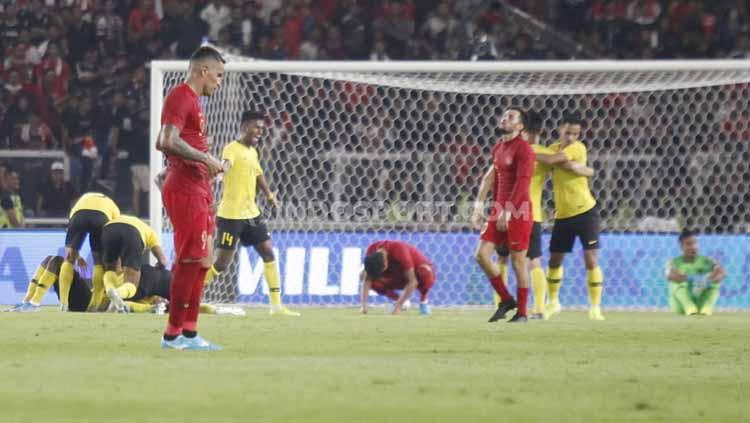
[666,229,726,316]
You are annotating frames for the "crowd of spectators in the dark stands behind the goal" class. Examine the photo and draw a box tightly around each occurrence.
[0,0,750,230]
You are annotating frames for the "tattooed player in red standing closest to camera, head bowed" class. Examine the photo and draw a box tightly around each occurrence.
[156,47,224,350]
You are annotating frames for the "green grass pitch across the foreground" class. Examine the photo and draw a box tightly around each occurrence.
[0,308,750,423]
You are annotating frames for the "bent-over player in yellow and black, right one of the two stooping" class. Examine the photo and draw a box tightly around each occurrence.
[95,215,167,312]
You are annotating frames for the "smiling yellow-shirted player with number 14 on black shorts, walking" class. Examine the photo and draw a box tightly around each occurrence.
[206,110,300,316]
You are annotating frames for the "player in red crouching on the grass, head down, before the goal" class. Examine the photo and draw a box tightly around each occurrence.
[360,241,435,315]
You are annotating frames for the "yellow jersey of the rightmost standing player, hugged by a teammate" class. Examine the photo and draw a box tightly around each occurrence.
[549,141,596,219]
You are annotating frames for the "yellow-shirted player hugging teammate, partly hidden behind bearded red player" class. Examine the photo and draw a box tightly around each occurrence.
[495,110,594,319]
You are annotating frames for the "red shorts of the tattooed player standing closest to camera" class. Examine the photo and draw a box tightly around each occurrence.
[161,190,216,261]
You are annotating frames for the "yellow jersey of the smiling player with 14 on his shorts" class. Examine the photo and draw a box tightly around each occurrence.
[216,141,263,219]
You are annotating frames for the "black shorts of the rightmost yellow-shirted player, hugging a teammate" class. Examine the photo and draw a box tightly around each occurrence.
[549,206,601,253]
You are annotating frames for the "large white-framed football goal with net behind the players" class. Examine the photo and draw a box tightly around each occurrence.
[151,61,750,308]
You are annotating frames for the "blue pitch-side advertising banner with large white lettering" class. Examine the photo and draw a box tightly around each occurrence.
[0,231,750,308]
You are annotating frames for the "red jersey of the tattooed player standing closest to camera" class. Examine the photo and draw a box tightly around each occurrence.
[161,83,212,200]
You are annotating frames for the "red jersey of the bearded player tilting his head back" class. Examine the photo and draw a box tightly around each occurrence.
[490,135,535,221]
